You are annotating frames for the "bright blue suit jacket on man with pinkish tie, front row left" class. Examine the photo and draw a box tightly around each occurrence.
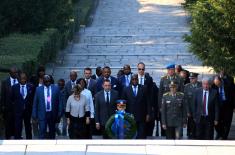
[32,84,63,121]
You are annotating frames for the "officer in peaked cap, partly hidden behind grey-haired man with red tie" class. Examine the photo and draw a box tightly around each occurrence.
[184,72,202,139]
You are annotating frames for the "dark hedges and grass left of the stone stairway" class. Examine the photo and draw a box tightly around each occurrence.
[0,0,96,76]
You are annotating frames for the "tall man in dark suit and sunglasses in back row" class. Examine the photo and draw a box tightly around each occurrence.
[137,62,155,136]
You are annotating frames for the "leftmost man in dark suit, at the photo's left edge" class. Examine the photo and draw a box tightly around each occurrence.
[1,67,18,139]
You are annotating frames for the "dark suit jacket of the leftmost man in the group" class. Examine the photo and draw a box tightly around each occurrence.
[1,77,13,114]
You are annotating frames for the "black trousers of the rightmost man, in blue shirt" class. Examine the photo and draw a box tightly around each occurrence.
[215,102,233,140]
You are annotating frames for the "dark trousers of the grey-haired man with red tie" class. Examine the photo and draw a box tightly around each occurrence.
[196,116,214,140]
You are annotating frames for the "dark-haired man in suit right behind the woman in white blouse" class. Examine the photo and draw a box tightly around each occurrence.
[84,67,96,97]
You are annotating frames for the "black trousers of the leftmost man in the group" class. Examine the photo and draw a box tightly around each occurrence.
[4,108,15,139]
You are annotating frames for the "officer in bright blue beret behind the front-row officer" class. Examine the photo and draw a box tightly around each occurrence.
[158,64,184,136]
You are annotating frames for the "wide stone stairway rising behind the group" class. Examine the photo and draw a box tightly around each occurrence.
[47,0,213,84]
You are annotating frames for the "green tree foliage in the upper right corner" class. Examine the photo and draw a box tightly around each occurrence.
[186,0,235,75]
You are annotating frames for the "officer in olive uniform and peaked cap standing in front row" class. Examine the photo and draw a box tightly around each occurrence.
[161,81,186,139]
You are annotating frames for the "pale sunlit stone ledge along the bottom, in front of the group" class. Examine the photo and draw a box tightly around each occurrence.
[0,140,235,155]
